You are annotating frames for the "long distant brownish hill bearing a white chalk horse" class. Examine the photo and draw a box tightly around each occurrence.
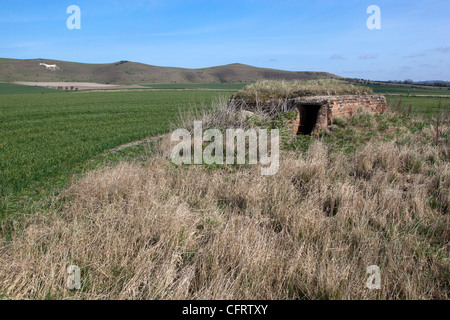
[0,58,339,84]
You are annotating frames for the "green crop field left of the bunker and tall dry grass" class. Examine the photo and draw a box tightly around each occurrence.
[0,87,236,215]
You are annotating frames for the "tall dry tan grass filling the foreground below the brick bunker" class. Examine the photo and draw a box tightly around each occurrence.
[0,115,450,299]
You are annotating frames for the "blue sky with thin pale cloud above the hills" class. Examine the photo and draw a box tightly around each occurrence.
[0,0,450,81]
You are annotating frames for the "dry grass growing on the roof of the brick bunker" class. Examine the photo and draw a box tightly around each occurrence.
[235,80,373,100]
